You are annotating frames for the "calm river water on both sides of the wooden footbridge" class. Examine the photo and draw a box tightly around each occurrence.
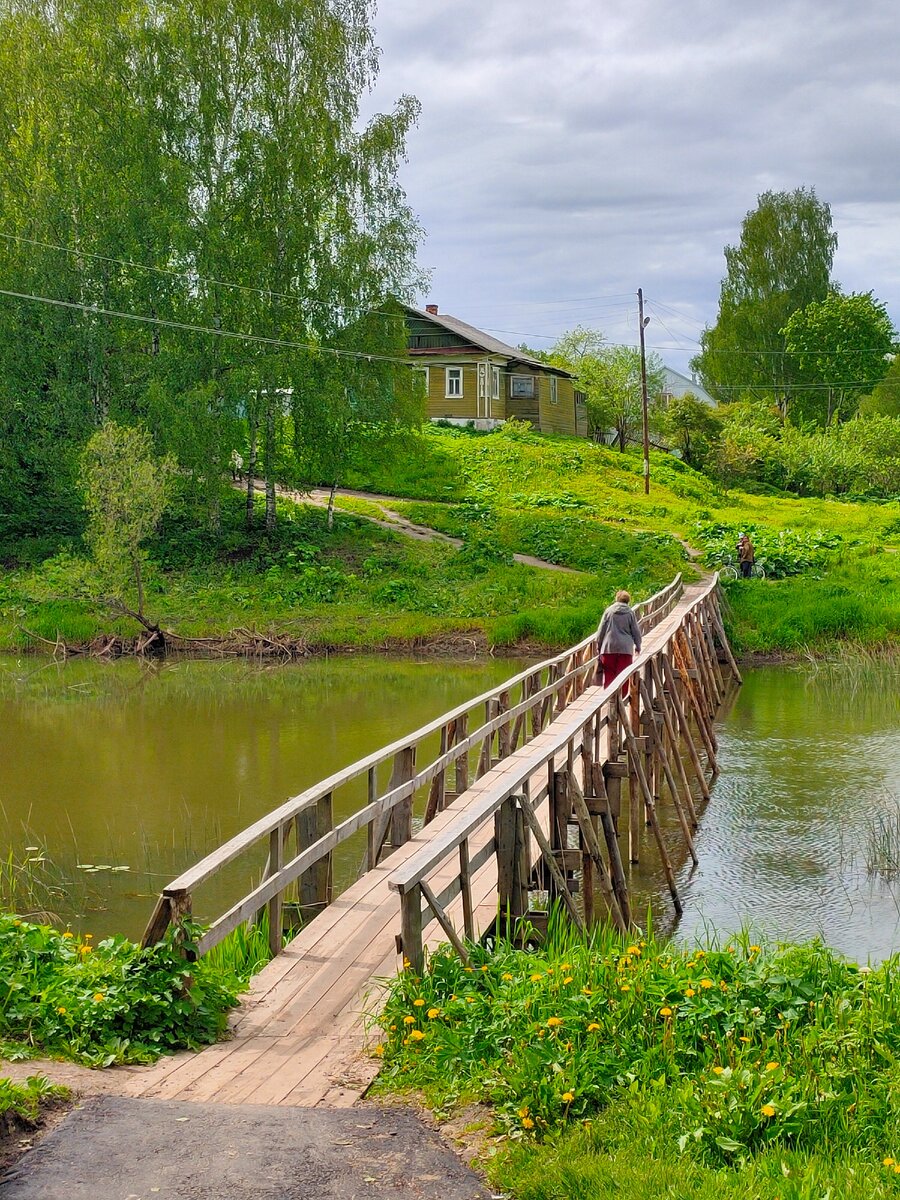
[0,658,900,959]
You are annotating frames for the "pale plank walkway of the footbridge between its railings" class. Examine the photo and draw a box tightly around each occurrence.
[124,584,707,1106]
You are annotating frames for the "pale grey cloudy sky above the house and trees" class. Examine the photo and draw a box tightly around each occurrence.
[364,0,900,370]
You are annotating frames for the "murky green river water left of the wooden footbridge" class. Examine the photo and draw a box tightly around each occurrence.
[0,656,524,936]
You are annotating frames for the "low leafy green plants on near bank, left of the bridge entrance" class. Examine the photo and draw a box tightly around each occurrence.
[0,914,240,1067]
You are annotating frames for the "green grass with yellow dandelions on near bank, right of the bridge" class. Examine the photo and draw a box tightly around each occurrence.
[377,926,900,1200]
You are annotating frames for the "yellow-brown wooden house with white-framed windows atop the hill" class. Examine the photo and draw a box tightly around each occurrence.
[404,304,588,437]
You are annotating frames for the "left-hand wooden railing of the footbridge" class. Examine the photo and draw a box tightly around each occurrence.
[143,575,683,954]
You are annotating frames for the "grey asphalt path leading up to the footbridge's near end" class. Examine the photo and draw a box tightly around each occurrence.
[0,1096,490,1200]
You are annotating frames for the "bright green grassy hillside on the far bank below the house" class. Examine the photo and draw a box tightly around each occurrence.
[0,422,900,652]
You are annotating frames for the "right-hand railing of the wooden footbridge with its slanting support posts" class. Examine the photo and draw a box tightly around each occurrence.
[389,580,740,970]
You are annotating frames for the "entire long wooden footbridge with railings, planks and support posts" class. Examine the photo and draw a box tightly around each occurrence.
[126,576,740,1105]
